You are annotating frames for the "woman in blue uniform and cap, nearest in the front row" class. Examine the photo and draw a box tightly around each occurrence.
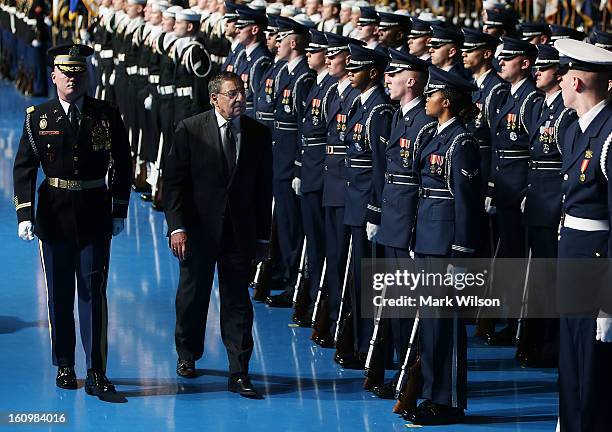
[409,67,482,425]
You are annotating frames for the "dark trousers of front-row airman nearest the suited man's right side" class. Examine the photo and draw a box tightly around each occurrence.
[272,181,304,293]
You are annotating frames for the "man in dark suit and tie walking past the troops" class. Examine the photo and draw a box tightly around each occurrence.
[163,72,272,398]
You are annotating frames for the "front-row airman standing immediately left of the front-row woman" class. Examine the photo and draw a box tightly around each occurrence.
[371,49,435,399]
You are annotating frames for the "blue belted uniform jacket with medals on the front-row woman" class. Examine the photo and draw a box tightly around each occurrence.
[414,120,482,257]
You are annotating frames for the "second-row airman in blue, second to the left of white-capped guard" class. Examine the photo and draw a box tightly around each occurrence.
[485,37,542,346]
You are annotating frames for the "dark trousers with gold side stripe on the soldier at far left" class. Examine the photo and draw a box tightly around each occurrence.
[39,240,110,372]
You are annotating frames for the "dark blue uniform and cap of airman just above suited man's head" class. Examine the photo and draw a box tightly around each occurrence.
[233,5,272,118]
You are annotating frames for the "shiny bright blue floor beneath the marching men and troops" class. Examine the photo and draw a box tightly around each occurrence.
[0,80,557,432]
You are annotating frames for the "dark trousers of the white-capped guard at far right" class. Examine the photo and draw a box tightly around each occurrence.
[559,314,612,432]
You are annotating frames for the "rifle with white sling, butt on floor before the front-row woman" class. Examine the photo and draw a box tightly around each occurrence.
[393,310,422,414]
